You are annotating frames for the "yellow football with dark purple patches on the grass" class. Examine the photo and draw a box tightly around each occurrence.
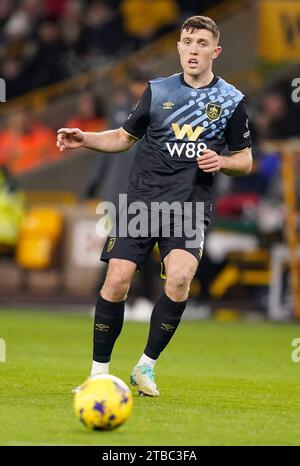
[74,375,132,430]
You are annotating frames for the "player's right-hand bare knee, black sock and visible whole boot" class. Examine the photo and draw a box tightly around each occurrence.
[131,249,198,396]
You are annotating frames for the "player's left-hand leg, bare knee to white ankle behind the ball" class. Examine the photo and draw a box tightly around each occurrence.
[91,259,136,375]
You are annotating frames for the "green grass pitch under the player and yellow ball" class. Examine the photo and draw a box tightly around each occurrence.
[0,310,300,446]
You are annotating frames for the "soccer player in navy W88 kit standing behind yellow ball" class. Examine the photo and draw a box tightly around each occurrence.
[57,16,252,396]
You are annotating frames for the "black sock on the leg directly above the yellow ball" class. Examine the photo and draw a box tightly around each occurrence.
[93,295,124,362]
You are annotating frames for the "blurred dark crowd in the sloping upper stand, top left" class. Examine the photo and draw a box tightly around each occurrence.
[0,0,221,99]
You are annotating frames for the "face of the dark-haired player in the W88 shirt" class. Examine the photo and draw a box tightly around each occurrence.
[177,29,222,76]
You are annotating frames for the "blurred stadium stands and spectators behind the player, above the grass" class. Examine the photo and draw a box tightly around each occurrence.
[0,0,300,320]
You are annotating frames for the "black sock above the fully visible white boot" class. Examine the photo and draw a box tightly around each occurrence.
[144,293,186,359]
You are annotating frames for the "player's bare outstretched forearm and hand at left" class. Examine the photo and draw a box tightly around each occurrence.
[56,128,136,152]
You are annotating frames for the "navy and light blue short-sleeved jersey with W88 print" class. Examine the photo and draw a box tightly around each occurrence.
[123,73,251,203]
